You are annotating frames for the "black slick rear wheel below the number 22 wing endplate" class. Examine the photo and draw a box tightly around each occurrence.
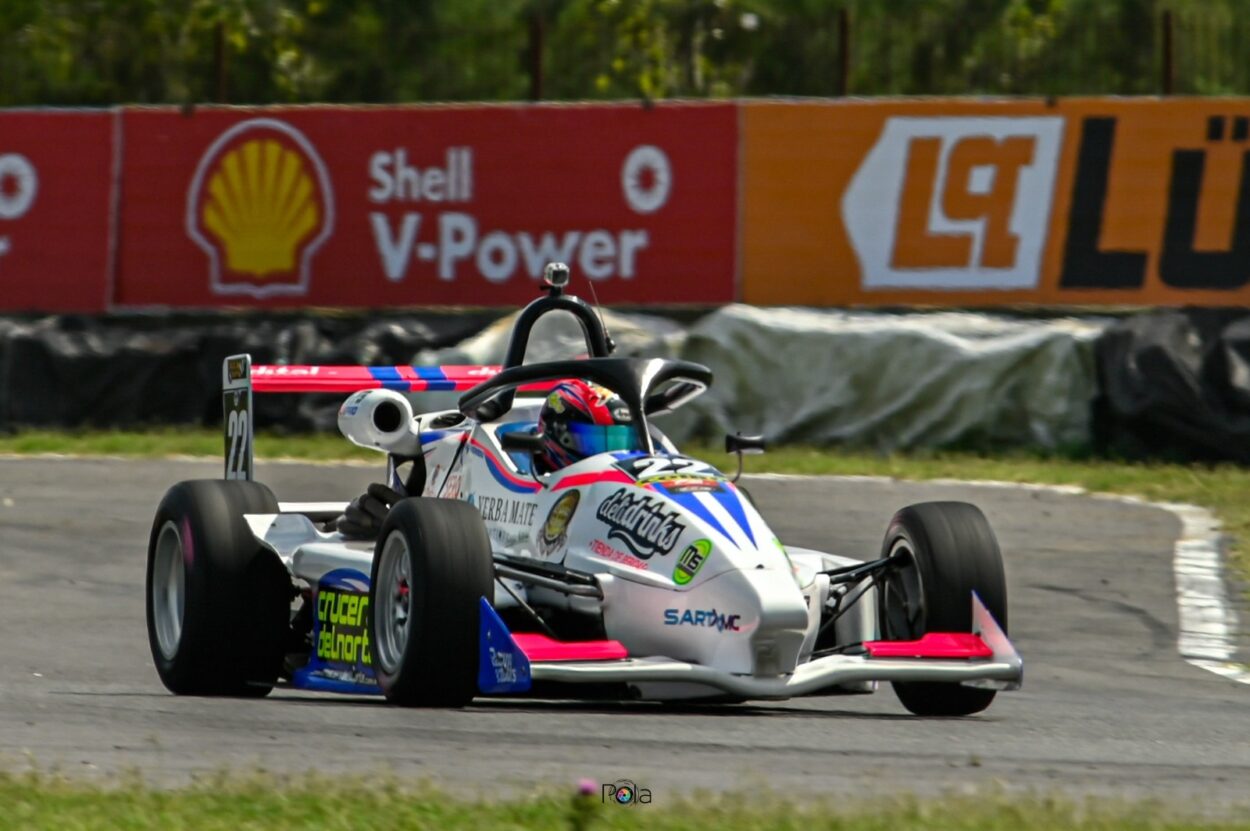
[146,480,291,697]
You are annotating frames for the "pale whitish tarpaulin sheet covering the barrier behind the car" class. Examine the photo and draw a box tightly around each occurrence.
[421,305,1105,451]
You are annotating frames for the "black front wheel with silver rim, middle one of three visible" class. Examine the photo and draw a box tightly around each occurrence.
[369,499,495,707]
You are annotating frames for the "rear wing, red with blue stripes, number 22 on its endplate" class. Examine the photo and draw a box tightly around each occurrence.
[221,355,500,481]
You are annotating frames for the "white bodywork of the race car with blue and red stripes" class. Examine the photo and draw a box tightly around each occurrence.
[238,390,1020,699]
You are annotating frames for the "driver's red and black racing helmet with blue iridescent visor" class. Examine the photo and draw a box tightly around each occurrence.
[539,379,641,470]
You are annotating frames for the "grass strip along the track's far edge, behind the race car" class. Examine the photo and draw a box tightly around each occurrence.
[0,427,1250,582]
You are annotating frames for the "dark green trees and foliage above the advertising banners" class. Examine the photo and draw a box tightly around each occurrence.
[0,0,1250,106]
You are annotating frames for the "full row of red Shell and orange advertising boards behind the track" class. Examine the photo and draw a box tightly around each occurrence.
[7,97,1250,312]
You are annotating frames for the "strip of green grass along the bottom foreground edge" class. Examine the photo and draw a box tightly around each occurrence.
[0,774,1250,831]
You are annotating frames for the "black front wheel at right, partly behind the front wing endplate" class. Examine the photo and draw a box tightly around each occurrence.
[879,502,1008,716]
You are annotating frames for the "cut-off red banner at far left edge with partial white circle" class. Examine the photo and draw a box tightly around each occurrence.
[0,110,118,312]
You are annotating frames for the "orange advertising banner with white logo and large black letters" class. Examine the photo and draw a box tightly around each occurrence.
[741,99,1250,306]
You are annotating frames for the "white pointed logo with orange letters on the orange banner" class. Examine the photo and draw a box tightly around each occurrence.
[841,116,1064,290]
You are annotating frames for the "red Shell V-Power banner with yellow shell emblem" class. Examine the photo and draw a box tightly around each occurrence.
[115,104,738,307]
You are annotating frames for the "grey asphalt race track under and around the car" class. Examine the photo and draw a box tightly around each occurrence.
[0,460,1250,806]
